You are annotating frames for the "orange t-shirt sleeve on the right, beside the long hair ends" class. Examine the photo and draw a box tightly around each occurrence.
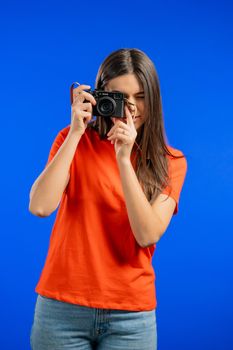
[161,152,187,215]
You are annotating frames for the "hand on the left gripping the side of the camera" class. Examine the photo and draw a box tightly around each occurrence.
[70,85,96,135]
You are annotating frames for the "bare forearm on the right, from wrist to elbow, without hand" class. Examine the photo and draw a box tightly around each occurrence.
[117,160,161,247]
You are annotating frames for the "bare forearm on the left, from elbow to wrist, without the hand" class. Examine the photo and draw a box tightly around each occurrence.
[29,133,81,216]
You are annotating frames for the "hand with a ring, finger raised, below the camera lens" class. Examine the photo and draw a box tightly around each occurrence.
[107,105,137,159]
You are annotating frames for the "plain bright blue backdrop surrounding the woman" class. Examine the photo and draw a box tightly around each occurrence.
[0,0,233,350]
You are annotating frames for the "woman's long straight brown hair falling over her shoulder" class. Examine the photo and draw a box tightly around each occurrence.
[89,48,184,203]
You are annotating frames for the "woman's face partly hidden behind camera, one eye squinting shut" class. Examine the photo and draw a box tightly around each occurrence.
[105,74,145,130]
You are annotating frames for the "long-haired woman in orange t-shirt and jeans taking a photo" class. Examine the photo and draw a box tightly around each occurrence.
[29,49,187,350]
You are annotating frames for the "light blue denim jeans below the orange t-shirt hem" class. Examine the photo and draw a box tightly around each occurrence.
[30,295,157,350]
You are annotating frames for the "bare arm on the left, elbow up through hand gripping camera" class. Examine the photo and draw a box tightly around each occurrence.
[29,85,96,217]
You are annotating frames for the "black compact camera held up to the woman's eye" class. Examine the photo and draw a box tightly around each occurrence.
[88,89,125,118]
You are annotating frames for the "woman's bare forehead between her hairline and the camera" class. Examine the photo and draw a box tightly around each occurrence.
[106,74,143,94]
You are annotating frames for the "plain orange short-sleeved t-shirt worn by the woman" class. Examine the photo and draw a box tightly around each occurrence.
[35,126,187,311]
